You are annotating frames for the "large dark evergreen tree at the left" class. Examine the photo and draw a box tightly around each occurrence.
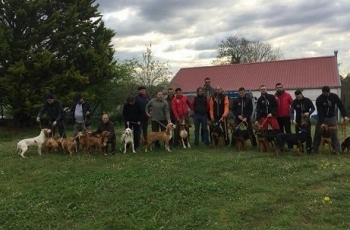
[0,0,114,126]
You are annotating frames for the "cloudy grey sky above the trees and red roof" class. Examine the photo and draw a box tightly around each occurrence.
[96,0,350,76]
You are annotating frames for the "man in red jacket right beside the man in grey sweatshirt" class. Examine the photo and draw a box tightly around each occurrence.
[171,88,193,146]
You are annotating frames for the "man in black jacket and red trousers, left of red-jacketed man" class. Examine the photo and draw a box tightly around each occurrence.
[255,85,280,133]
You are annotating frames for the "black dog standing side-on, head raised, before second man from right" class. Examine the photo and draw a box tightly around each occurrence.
[275,115,310,157]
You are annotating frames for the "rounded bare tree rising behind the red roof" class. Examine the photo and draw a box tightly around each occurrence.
[213,36,283,65]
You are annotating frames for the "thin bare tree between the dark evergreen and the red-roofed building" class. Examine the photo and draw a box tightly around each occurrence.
[133,43,172,96]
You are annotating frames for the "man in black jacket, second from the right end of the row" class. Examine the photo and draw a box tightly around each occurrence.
[290,90,315,154]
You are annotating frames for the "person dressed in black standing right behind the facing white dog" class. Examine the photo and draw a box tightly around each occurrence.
[123,97,142,150]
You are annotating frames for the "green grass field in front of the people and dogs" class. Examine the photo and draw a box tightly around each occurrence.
[0,128,350,230]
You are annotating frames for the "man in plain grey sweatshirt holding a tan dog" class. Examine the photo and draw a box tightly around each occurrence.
[145,91,171,148]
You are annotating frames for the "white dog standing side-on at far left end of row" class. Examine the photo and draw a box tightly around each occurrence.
[17,129,51,158]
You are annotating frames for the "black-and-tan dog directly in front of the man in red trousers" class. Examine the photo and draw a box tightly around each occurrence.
[253,124,277,152]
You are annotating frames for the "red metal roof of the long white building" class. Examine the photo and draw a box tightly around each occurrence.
[169,56,341,92]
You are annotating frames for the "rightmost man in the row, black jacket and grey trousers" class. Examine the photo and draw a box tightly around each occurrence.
[312,86,349,154]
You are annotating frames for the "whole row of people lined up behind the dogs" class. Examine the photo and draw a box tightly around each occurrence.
[37,78,349,154]
